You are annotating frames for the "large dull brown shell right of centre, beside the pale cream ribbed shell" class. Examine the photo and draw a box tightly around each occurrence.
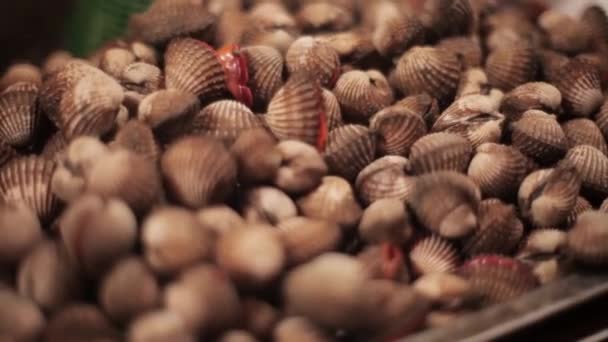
[409,171,481,239]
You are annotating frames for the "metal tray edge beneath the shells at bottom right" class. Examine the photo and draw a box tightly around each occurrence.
[401,273,608,342]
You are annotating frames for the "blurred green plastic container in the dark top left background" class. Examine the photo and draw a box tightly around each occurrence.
[66,0,152,57]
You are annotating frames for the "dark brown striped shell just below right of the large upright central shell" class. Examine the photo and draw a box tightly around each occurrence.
[324,125,376,180]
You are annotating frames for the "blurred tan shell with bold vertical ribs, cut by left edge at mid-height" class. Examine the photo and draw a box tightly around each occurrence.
[0,156,59,223]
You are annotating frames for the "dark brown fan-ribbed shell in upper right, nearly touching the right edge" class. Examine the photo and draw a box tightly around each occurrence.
[552,58,604,117]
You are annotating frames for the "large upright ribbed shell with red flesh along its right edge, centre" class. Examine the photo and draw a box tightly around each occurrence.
[265,74,325,145]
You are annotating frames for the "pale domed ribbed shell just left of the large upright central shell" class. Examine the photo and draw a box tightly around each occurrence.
[192,100,263,143]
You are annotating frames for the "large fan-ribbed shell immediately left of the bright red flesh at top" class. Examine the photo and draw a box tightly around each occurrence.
[165,38,226,102]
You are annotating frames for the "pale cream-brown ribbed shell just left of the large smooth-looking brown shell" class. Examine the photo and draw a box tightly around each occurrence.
[355,156,415,205]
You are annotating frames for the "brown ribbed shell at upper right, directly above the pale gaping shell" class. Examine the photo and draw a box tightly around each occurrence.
[485,41,538,91]
